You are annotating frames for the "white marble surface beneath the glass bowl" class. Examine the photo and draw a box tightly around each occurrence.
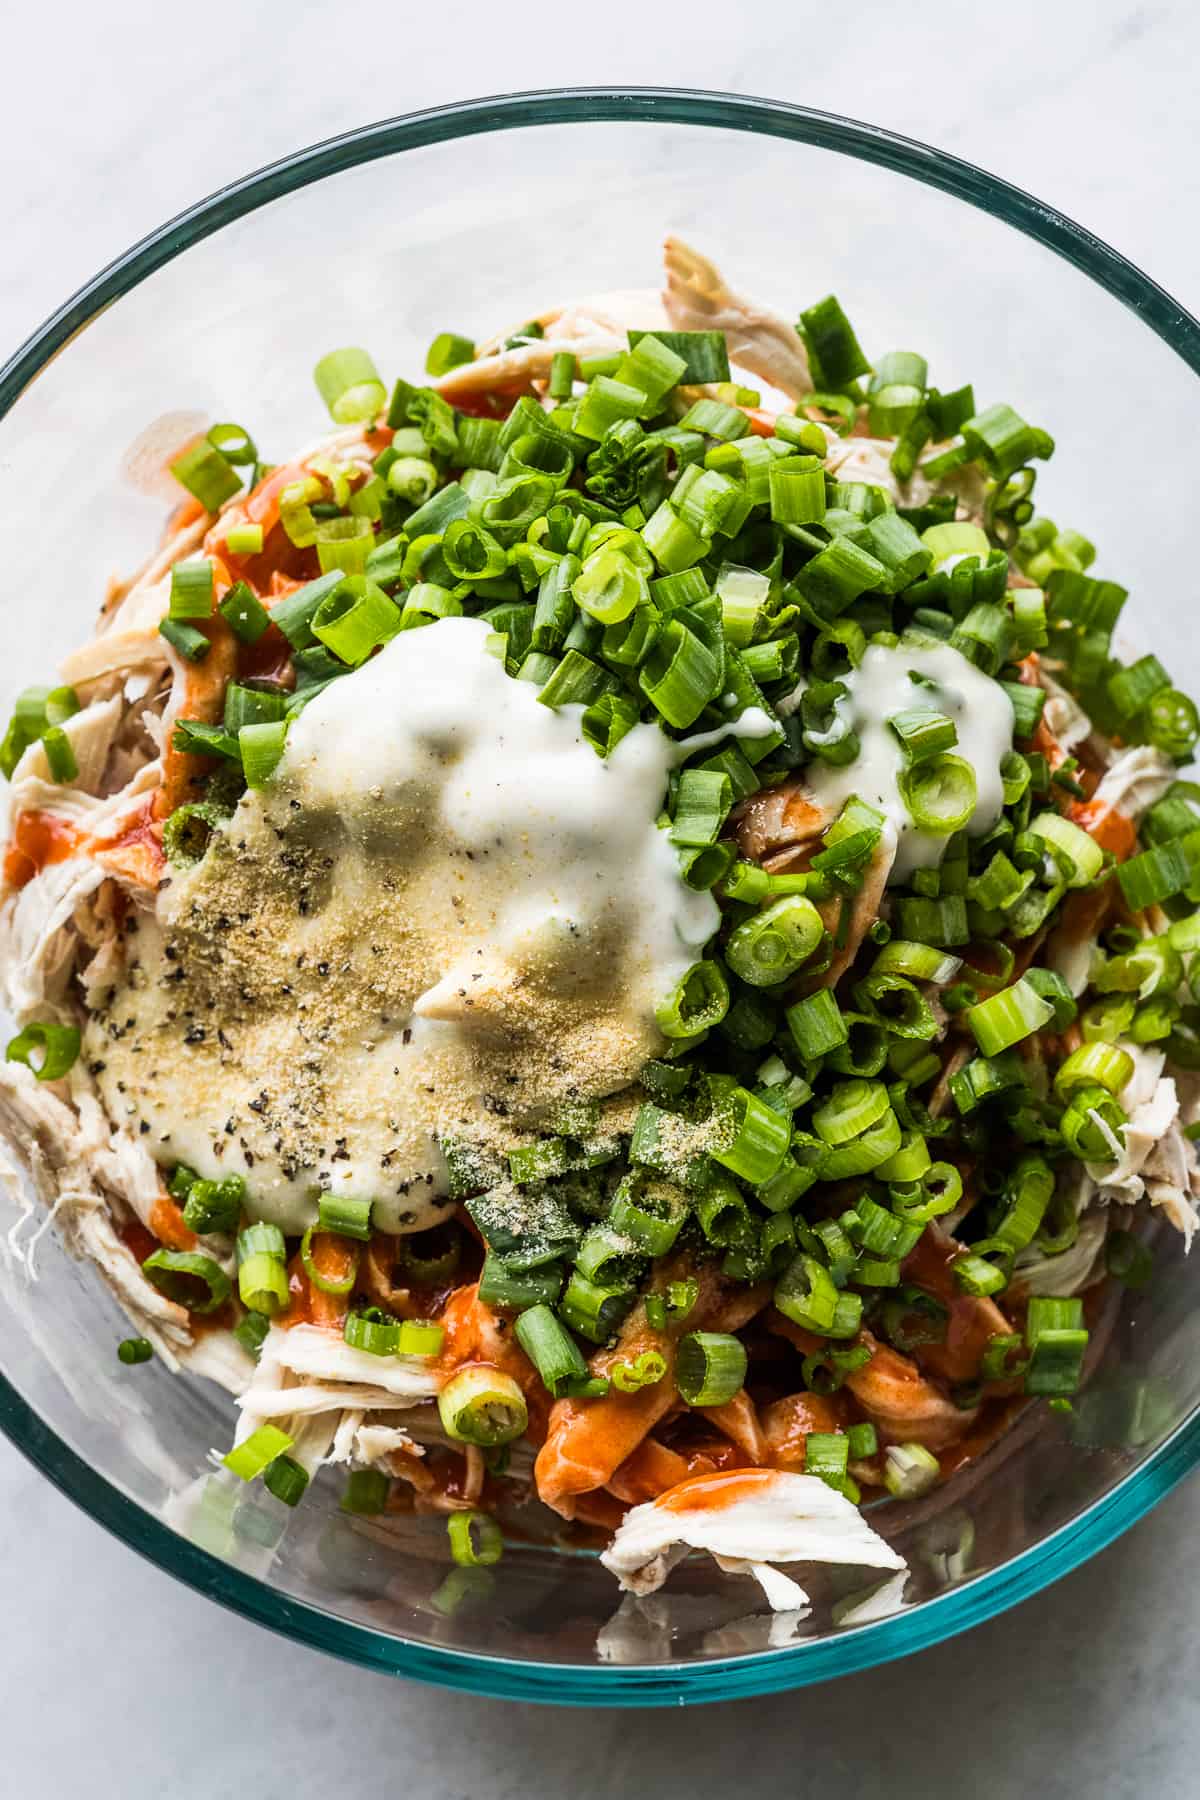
[0,0,1200,1800]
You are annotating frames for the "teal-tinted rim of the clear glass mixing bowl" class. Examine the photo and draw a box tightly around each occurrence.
[0,86,1200,1706]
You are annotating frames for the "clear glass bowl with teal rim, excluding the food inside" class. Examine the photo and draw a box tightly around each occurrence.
[0,90,1200,1705]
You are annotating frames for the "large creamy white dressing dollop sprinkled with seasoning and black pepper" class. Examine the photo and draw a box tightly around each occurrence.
[86,619,723,1231]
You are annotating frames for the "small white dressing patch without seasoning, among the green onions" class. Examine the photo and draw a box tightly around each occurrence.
[804,644,1013,882]
